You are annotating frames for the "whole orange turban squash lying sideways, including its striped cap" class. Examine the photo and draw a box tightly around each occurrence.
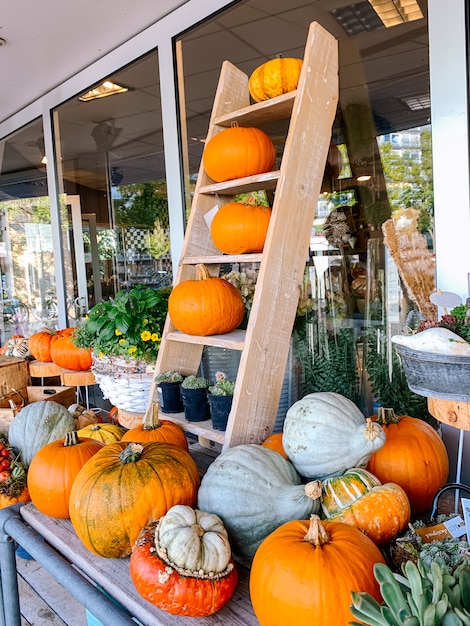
[322,468,411,546]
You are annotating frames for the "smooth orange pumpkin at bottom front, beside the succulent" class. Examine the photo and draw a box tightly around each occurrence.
[250,515,385,626]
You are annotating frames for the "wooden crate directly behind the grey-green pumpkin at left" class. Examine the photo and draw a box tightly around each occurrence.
[0,386,76,436]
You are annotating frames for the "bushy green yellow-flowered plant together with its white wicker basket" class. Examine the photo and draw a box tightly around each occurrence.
[74,285,171,414]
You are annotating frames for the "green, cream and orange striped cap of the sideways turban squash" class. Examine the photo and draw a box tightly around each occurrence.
[321,467,382,519]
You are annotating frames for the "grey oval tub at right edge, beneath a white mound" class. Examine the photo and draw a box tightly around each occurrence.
[394,344,470,402]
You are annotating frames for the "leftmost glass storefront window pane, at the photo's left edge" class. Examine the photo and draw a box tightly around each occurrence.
[0,120,57,345]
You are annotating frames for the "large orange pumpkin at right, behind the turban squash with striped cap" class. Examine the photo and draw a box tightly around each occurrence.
[367,408,449,515]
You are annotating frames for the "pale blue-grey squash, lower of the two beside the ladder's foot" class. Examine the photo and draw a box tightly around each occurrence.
[198,444,321,561]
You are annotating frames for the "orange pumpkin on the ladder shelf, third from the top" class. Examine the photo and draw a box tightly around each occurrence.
[211,196,271,254]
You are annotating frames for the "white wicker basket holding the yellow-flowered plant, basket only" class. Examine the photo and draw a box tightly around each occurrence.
[91,356,153,414]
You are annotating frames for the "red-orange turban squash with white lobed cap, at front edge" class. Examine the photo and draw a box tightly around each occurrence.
[129,505,238,617]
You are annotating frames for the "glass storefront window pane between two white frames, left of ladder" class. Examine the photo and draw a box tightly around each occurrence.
[54,47,172,325]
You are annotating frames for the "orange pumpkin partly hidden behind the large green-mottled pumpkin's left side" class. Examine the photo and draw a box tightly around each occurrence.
[28,431,104,519]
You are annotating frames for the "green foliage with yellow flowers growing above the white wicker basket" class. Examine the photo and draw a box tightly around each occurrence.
[74,285,170,363]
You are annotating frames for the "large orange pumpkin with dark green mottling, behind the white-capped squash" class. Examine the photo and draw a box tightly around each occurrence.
[69,441,200,558]
